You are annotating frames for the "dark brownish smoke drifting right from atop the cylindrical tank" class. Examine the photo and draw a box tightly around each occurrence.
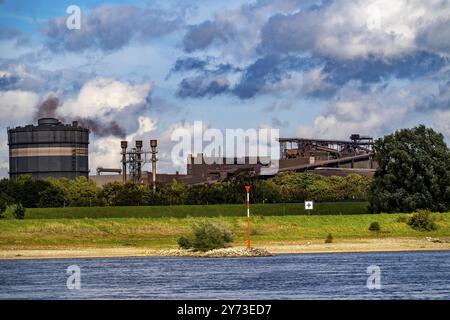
[34,95,126,138]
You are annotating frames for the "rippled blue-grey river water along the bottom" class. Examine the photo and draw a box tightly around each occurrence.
[0,251,450,299]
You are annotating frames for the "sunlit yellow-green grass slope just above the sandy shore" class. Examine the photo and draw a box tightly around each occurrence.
[0,212,450,250]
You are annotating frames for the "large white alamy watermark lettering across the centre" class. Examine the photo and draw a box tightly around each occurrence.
[170,121,280,175]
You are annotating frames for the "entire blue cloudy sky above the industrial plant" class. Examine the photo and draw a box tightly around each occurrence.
[0,0,450,176]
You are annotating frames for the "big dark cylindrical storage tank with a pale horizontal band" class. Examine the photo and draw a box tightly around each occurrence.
[8,118,89,179]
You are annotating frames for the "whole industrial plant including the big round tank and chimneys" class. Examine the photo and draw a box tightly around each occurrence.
[8,118,377,188]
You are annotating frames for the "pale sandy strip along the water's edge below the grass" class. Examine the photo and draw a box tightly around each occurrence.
[0,238,450,259]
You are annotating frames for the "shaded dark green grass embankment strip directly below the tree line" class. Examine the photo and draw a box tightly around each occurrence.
[26,202,368,219]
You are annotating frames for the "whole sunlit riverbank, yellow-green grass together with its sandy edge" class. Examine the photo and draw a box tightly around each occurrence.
[0,213,450,259]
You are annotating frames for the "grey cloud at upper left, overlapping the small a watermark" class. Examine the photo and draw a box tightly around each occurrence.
[43,5,183,52]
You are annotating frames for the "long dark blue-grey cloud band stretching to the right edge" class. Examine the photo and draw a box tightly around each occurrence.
[171,51,449,99]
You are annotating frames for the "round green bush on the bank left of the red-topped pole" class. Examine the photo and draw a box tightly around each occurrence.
[192,221,233,251]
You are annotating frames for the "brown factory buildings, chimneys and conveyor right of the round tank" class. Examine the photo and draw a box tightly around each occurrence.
[91,134,377,188]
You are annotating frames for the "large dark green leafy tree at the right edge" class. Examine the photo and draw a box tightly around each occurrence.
[369,125,450,212]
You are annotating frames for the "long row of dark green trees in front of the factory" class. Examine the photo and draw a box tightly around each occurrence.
[0,171,371,208]
